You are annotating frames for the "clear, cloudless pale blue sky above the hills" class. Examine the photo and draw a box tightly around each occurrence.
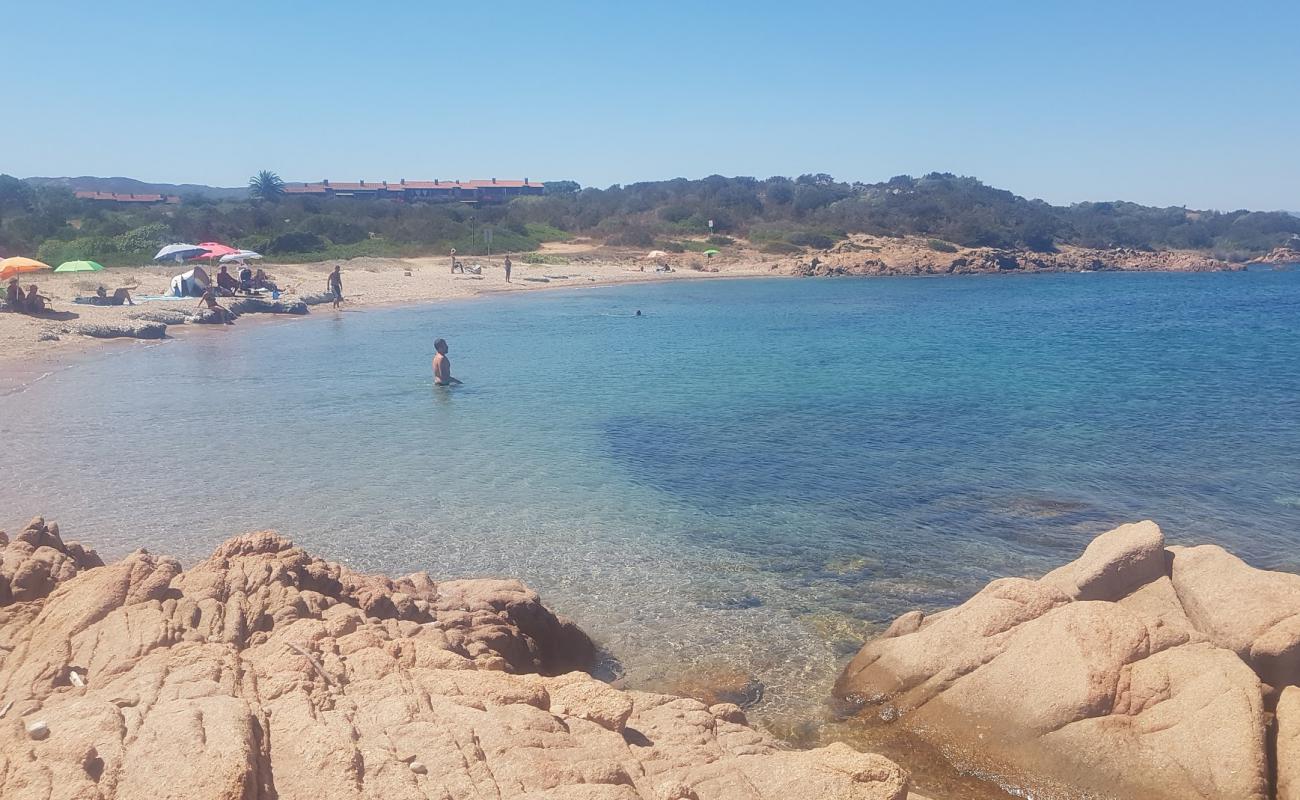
[0,0,1300,209]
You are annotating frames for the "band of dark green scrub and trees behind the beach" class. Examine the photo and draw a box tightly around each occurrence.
[0,173,1300,264]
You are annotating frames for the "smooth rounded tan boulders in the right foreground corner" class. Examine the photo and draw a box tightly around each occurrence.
[836,522,1300,800]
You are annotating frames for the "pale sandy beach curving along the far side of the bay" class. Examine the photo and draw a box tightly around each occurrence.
[0,239,784,393]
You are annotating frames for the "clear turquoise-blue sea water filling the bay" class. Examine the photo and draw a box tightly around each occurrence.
[0,272,1300,733]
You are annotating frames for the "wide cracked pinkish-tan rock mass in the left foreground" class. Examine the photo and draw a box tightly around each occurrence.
[0,519,915,800]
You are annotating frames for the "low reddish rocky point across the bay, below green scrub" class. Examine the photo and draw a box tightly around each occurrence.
[784,234,1245,276]
